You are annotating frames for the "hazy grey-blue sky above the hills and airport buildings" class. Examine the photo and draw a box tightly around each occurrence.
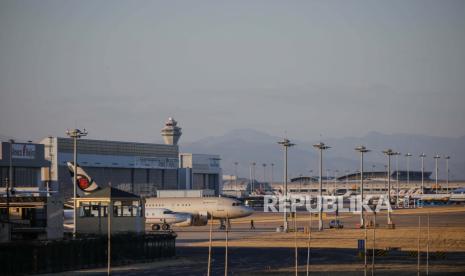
[0,0,465,144]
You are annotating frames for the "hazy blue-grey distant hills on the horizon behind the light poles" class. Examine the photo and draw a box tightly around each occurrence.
[181,129,465,181]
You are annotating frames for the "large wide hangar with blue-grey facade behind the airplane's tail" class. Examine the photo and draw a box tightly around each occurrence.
[41,137,178,198]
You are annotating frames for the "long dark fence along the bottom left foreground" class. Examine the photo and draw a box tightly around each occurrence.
[0,233,176,275]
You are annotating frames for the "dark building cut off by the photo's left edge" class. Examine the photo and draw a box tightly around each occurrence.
[0,141,63,242]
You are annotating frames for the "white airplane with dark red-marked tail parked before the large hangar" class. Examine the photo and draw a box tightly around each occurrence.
[67,162,253,230]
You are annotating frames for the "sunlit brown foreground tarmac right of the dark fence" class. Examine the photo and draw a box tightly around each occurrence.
[50,205,465,275]
